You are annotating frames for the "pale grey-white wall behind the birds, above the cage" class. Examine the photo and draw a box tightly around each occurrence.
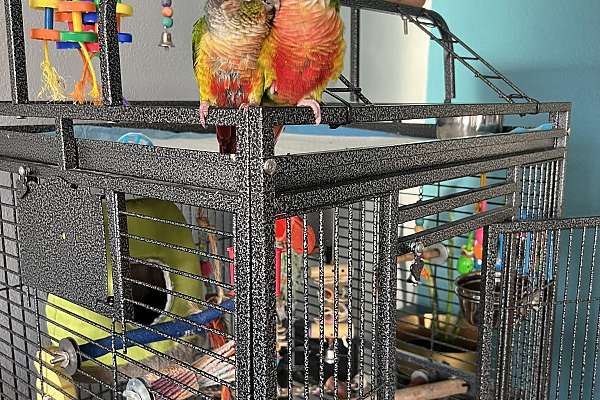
[0,0,429,102]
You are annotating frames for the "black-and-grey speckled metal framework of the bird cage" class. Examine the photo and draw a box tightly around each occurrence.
[0,0,570,399]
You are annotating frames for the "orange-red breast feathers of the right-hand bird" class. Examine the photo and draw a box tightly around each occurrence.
[271,1,345,104]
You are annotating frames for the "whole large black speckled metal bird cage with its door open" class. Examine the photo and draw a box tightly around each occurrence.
[0,0,580,400]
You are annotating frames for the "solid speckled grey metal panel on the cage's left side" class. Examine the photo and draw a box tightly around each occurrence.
[17,177,112,315]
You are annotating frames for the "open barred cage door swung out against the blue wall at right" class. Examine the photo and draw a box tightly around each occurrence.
[479,217,600,399]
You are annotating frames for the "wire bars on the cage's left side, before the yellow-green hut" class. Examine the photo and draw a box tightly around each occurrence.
[0,176,235,399]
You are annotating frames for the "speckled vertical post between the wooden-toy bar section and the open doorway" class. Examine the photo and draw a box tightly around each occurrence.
[375,190,399,400]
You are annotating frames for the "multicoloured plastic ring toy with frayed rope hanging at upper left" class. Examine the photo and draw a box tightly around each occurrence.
[29,0,133,105]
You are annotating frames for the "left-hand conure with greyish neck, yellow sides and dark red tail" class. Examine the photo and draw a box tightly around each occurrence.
[192,0,274,154]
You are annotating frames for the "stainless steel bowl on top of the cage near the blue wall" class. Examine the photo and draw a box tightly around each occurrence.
[436,115,504,139]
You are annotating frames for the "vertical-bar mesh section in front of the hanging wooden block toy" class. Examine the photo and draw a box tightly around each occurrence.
[276,199,390,399]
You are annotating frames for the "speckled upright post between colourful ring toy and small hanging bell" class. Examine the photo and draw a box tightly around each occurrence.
[97,0,123,106]
